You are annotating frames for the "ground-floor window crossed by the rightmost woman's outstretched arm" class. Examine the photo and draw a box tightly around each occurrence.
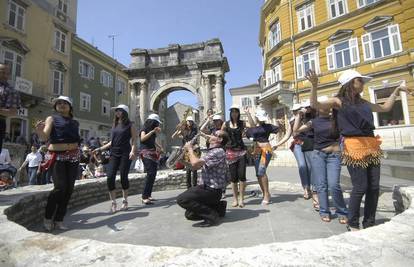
[374,86,405,126]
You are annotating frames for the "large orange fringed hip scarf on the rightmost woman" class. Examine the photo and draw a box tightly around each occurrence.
[342,135,382,168]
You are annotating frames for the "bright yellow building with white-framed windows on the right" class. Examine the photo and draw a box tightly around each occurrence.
[259,0,414,148]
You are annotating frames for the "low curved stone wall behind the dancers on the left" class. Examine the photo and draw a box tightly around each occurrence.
[0,171,186,227]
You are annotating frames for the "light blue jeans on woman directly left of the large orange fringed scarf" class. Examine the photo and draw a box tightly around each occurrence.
[312,150,348,217]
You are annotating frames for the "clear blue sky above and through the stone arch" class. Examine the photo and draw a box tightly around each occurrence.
[77,0,263,119]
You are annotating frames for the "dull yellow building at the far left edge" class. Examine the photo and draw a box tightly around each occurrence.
[0,0,77,144]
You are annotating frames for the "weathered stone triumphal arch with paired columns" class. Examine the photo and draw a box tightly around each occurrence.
[126,39,229,129]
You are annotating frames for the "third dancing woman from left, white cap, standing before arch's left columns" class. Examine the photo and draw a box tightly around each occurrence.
[139,114,162,205]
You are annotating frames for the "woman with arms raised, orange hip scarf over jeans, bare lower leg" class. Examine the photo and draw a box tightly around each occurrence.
[245,108,279,205]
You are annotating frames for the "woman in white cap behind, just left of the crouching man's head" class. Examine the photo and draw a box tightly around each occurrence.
[171,116,200,188]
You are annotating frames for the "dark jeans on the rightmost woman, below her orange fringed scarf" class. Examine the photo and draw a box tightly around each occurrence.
[348,164,381,228]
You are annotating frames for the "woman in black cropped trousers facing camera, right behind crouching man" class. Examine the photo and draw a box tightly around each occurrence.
[222,105,247,208]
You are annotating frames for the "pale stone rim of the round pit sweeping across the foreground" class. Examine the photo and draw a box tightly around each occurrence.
[0,177,414,267]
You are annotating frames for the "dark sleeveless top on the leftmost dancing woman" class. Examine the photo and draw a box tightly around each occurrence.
[50,114,80,144]
